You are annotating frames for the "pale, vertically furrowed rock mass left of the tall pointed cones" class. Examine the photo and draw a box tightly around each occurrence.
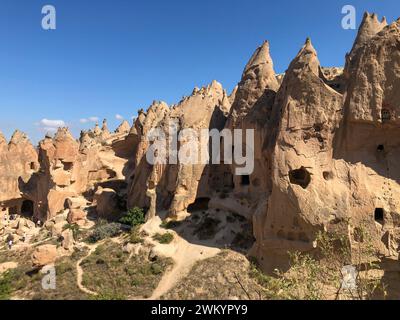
[128,81,230,217]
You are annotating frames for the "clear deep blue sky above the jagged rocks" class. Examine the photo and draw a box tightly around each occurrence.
[0,0,400,142]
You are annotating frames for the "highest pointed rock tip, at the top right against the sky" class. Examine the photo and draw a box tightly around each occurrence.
[350,12,388,57]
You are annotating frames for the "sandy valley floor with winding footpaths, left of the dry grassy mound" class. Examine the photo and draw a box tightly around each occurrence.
[0,198,253,300]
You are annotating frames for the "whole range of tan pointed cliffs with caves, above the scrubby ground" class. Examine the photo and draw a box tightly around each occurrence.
[0,13,400,276]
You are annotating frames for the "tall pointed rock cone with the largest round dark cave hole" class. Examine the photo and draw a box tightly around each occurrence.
[254,39,345,267]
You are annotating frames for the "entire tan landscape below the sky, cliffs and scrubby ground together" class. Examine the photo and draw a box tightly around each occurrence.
[0,13,400,299]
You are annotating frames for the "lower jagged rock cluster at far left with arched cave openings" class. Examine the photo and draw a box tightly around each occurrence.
[0,121,135,221]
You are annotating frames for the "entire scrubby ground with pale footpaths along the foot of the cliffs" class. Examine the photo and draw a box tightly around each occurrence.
[0,199,398,300]
